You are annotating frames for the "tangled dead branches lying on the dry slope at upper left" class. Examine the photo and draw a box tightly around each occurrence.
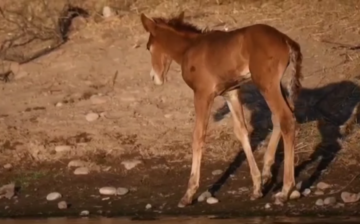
[0,3,89,64]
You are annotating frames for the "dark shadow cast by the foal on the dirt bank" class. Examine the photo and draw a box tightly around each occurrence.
[209,78,360,198]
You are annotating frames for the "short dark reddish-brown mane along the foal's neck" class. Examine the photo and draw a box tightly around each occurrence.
[153,17,207,34]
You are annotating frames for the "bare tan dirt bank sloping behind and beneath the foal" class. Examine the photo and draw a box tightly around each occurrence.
[0,0,360,217]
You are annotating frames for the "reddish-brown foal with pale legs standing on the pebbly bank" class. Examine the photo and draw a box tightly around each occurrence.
[141,12,302,207]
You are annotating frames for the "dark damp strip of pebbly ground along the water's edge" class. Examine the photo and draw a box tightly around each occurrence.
[0,160,360,218]
